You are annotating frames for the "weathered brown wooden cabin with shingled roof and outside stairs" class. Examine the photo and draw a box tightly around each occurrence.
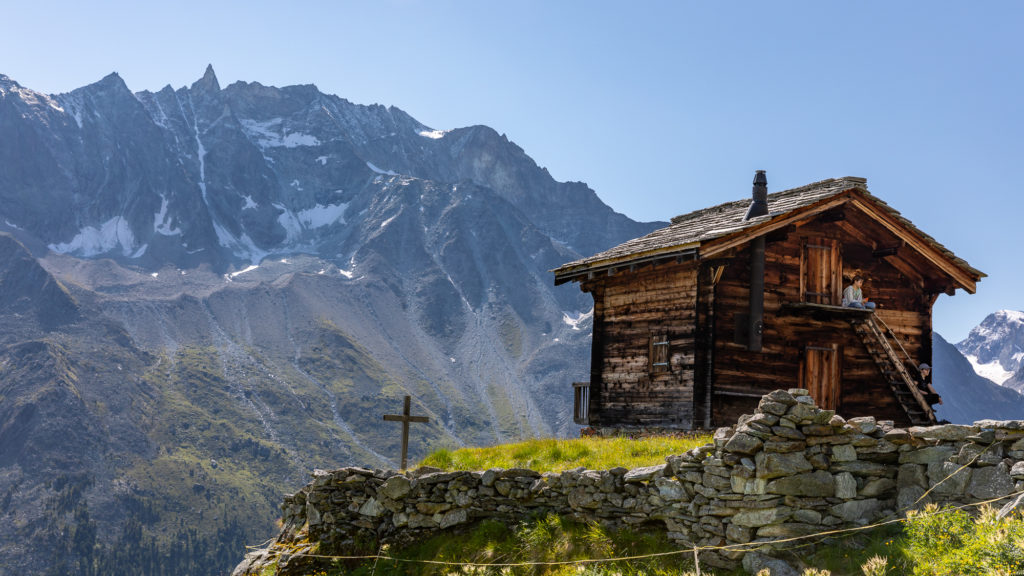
[552,171,985,429]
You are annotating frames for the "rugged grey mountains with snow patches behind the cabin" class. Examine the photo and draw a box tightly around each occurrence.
[0,68,1024,576]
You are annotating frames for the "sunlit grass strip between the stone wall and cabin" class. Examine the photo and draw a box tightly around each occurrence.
[420,436,711,472]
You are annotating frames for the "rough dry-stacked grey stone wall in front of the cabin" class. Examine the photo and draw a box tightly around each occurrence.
[234,389,1024,575]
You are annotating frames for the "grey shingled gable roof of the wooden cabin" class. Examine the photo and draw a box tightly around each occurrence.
[551,172,985,284]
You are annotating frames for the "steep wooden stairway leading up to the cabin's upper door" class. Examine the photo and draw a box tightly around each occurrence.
[851,313,936,425]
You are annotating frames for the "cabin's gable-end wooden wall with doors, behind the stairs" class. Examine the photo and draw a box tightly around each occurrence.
[713,210,937,425]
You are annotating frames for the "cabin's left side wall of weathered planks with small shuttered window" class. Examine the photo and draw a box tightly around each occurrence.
[583,261,697,428]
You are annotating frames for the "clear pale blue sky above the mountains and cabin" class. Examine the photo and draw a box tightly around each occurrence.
[0,0,1024,341]
